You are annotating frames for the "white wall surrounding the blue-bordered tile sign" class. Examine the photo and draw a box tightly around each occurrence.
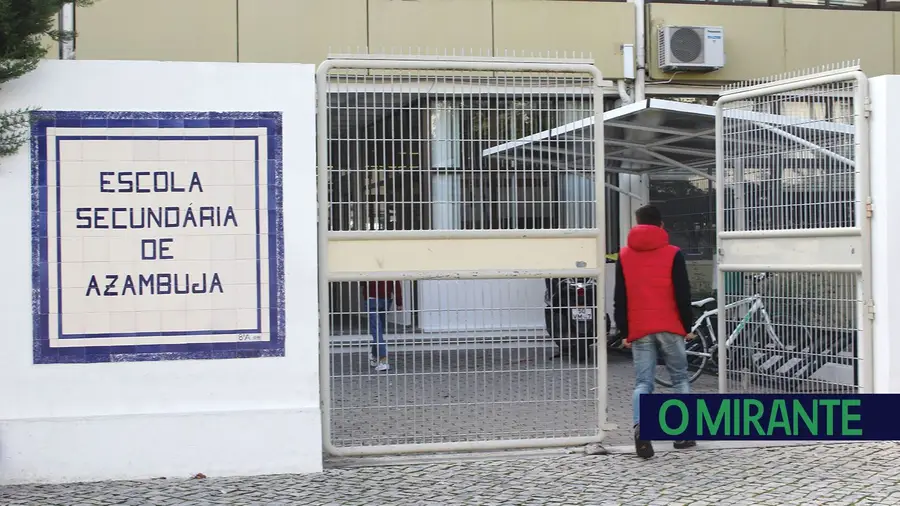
[0,61,322,483]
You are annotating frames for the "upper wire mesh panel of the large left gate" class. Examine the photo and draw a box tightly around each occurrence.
[328,70,596,235]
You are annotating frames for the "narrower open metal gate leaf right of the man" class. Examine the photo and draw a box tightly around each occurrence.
[714,66,874,393]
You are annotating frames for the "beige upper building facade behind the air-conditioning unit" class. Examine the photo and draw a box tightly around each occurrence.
[50,0,900,85]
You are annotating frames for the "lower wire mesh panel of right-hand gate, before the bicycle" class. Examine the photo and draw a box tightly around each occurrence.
[725,272,861,393]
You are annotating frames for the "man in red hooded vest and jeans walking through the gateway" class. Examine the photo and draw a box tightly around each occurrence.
[614,205,697,458]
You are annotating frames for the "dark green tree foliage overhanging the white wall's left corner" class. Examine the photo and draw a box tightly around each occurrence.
[0,0,93,156]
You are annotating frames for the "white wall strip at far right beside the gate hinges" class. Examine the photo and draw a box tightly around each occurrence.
[869,75,900,393]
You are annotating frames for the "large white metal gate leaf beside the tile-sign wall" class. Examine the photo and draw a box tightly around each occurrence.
[317,56,606,456]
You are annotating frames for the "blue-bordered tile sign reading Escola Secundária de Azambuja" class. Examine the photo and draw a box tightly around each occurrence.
[31,111,284,363]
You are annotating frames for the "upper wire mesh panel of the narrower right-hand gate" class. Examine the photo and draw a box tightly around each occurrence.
[723,81,858,231]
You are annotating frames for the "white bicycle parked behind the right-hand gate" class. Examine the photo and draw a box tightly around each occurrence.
[655,273,809,387]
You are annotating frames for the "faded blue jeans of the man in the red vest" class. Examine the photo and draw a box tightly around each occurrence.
[631,332,691,425]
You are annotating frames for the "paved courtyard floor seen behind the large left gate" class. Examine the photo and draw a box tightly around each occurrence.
[330,343,718,446]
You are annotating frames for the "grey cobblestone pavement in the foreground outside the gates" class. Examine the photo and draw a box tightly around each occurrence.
[0,443,900,506]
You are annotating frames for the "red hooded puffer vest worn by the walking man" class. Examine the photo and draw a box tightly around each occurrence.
[619,225,684,342]
